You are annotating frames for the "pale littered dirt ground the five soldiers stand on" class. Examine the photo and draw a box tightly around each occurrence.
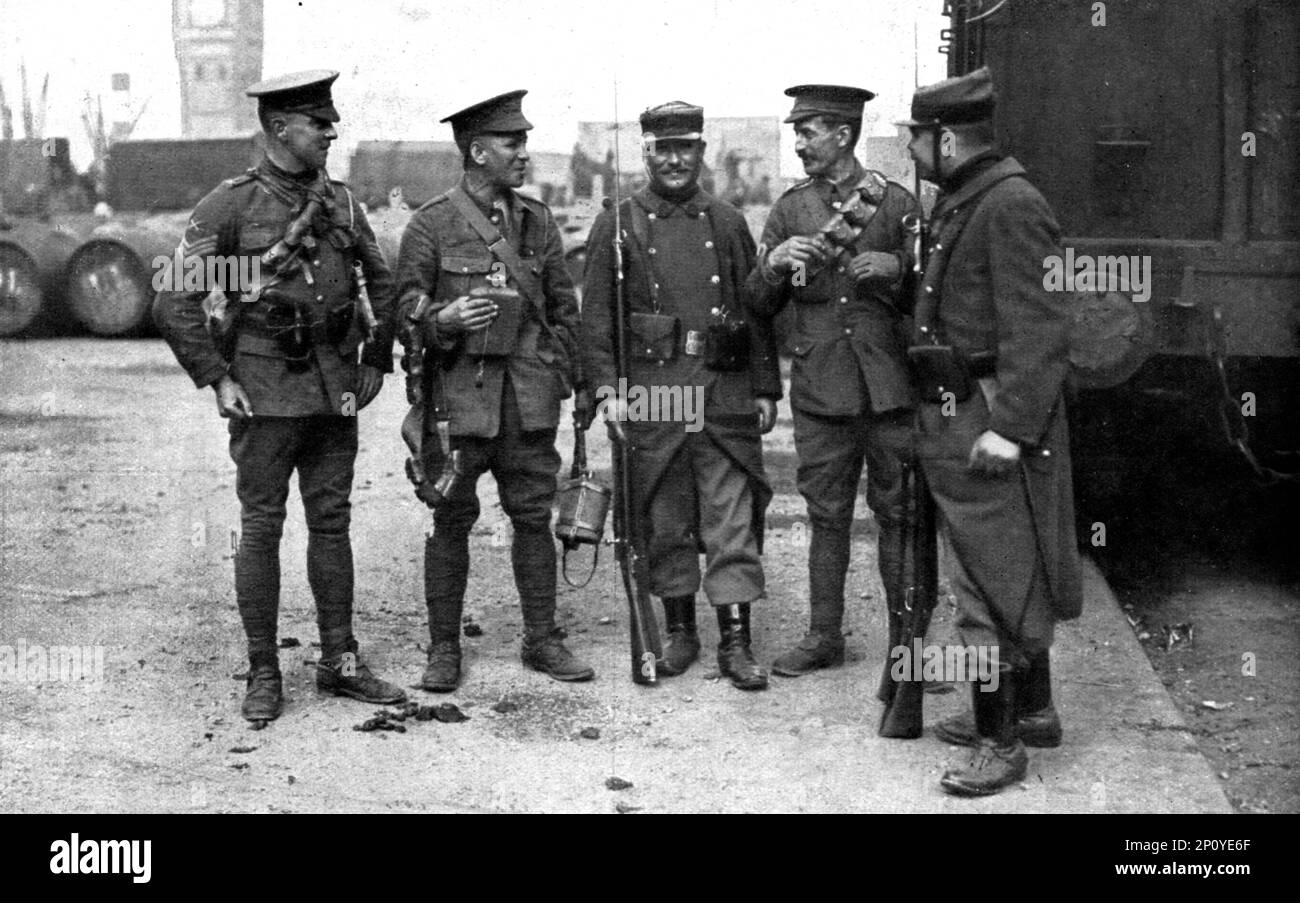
[0,339,1296,812]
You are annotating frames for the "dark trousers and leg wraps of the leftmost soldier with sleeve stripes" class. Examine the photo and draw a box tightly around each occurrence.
[229,414,356,657]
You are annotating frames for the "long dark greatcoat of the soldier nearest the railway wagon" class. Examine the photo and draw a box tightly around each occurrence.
[915,157,1082,667]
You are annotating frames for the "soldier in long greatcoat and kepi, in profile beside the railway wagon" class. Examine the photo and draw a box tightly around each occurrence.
[905,69,1082,795]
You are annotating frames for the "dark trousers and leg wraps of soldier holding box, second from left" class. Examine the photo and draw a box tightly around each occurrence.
[424,374,560,641]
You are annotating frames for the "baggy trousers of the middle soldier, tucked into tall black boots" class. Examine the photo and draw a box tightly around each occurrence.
[646,430,763,605]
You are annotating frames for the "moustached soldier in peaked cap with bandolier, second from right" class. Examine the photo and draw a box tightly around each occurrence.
[749,84,917,677]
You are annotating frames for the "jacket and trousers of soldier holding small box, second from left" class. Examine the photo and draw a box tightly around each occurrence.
[397,181,581,639]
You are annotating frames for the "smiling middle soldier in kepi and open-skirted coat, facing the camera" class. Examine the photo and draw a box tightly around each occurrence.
[582,101,781,690]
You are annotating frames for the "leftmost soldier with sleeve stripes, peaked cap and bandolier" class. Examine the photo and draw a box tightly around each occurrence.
[153,70,406,721]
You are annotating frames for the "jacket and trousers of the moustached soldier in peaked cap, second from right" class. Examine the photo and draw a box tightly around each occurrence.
[749,162,917,637]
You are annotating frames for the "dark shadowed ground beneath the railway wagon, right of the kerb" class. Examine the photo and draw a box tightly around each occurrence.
[1095,384,1300,812]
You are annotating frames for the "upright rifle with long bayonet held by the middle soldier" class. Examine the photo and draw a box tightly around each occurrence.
[605,82,663,685]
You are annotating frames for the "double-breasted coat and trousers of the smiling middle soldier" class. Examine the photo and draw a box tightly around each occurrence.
[582,188,781,605]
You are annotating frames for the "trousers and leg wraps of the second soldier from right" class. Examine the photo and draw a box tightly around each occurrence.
[794,408,913,637]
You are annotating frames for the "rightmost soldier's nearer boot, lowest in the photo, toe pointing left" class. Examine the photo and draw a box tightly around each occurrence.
[939,667,1030,796]
